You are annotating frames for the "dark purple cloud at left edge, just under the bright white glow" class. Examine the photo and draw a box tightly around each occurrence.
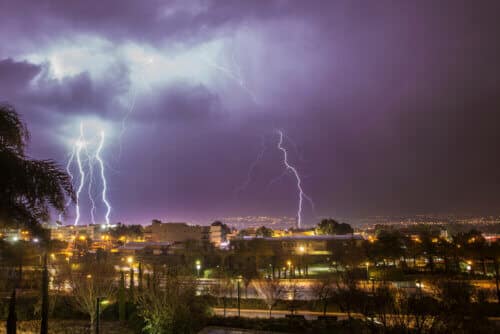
[0,59,130,118]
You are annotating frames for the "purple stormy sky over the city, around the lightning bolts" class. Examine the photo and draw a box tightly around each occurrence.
[0,0,500,227]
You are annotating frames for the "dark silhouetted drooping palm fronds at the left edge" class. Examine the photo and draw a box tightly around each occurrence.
[0,104,75,234]
